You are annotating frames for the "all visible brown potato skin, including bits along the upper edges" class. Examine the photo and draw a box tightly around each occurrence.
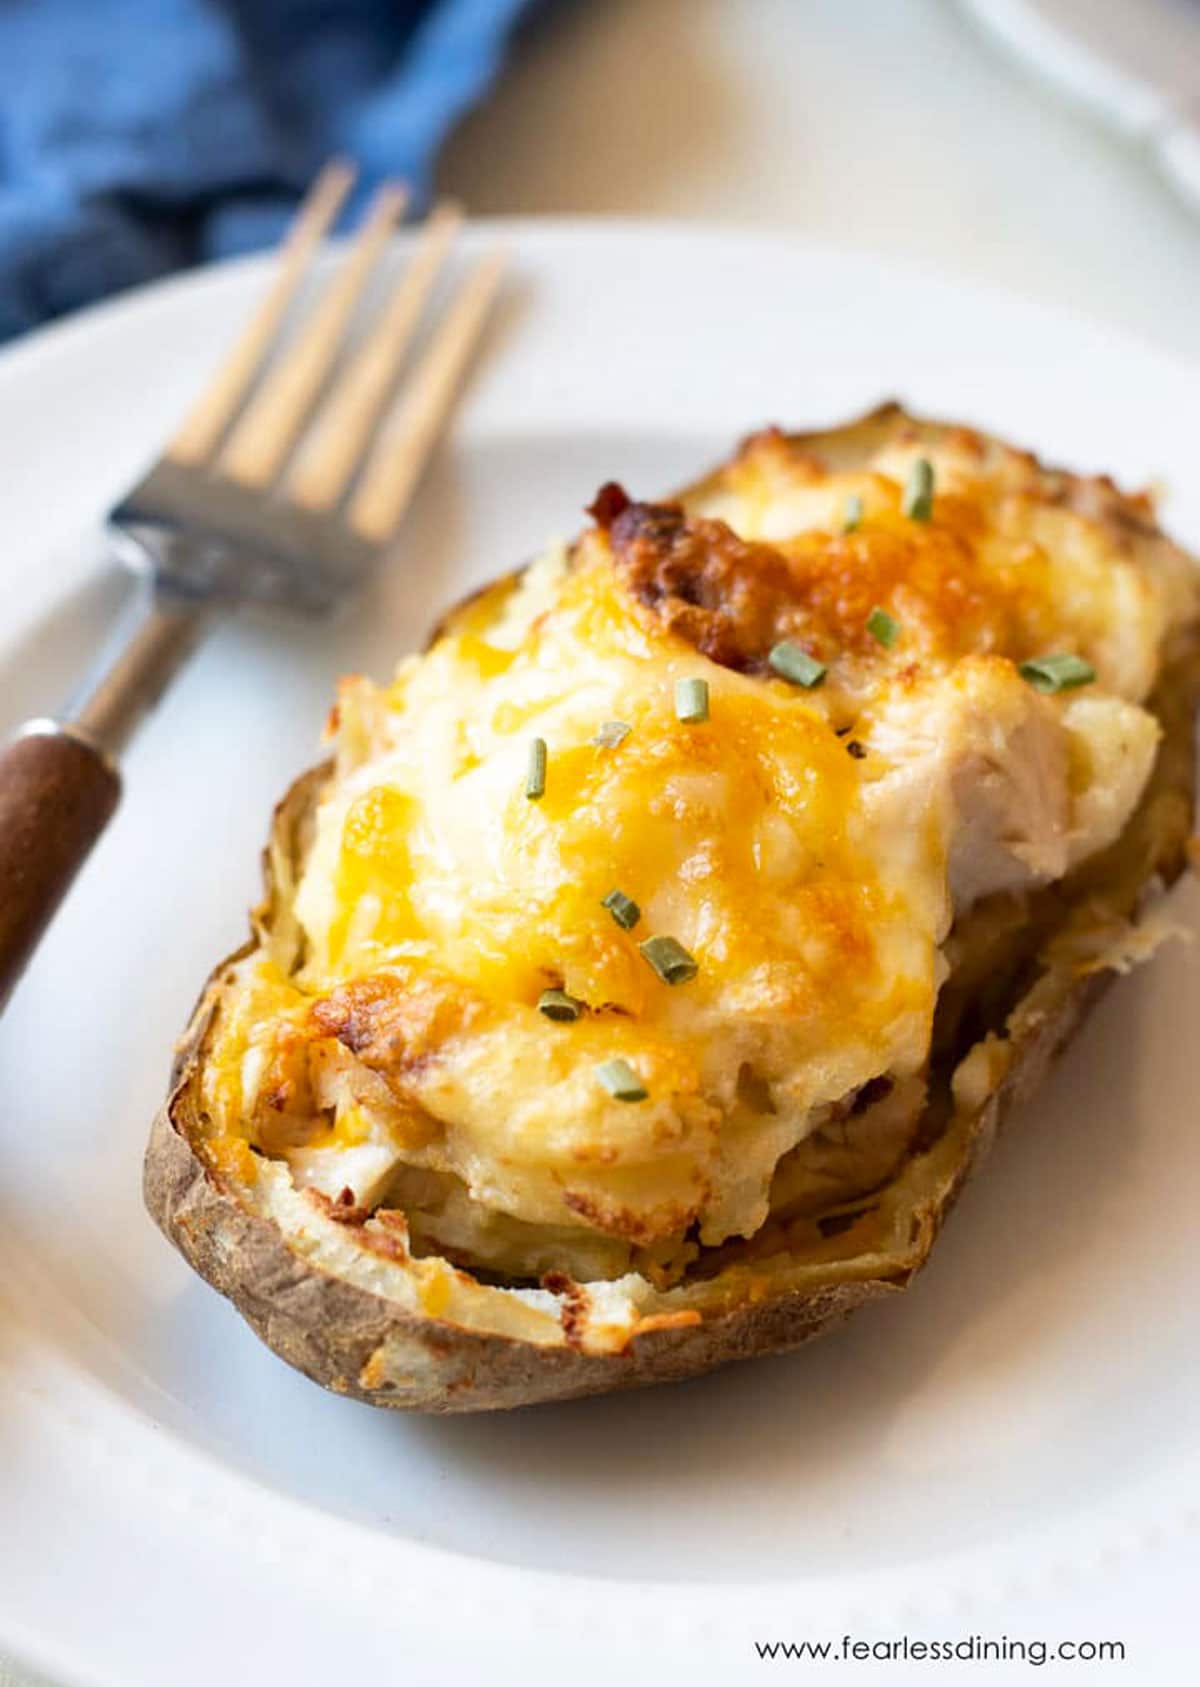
[143,408,1198,1412]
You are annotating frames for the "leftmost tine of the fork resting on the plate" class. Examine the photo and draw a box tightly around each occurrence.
[165,159,354,464]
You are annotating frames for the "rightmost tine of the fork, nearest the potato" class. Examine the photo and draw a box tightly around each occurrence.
[348,251,505,543]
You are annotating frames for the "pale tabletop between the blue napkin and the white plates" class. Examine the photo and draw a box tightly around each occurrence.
[9,0,1200,1687]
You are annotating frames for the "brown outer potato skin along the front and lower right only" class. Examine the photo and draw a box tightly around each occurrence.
[143,962,1111,1412]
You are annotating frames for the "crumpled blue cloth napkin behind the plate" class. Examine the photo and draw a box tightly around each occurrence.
[0,0,532,339]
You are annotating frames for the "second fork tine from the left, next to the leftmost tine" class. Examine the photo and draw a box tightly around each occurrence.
[218,182,408,488]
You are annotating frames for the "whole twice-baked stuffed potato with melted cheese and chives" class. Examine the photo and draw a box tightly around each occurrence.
[145,405,1200,1412]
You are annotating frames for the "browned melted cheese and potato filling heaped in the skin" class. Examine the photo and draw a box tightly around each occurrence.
[199,418,1192,1275]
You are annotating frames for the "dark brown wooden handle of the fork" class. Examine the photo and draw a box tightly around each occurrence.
[0,720,122,1012]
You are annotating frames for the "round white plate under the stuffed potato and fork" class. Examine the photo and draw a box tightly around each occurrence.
[0,223,1200,1687]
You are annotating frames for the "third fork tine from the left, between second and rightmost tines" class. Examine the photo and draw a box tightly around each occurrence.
[287,202,462,509]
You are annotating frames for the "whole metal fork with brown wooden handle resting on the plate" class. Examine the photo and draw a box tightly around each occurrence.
[0,162,503,1011]
